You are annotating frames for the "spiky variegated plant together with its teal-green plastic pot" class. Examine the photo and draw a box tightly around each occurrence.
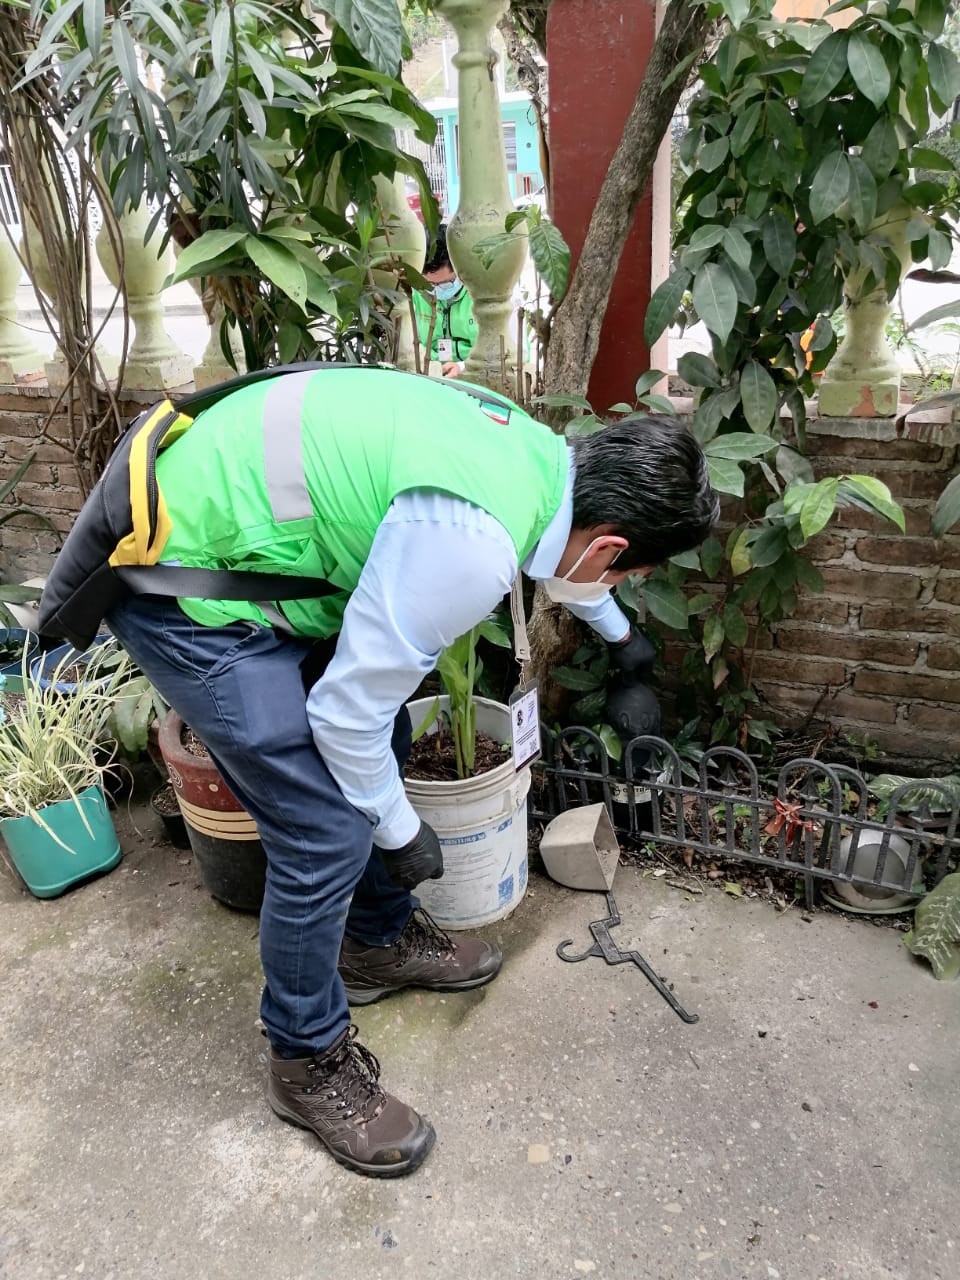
[0,648,128,897]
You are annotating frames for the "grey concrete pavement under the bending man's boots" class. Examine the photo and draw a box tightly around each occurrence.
[0,806,960,1280]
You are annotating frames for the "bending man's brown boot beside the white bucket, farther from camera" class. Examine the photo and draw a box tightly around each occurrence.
[339,910,503,1005]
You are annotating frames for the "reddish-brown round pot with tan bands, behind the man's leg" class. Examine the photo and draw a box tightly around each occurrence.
[160,710,266,911]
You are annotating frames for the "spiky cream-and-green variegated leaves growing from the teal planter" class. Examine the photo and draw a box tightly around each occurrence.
[0,641,131,831]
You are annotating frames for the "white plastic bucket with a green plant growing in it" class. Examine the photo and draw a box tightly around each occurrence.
[404,618,530,929]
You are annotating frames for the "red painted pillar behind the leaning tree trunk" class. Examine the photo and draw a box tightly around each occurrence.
[547,0,669,412]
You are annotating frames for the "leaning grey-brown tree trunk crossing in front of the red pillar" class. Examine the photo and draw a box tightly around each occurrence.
[544,0,709,396]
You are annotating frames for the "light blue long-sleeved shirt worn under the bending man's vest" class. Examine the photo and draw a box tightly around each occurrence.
[307,460,630,849]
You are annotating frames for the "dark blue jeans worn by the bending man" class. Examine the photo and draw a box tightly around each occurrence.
[108,596,417,1057]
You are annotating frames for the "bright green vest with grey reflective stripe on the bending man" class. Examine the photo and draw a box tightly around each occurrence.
[156,367,568,636]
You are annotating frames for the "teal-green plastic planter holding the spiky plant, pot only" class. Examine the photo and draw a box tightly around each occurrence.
[0,786,120,897]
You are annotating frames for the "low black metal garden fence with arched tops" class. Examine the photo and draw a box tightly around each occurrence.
[531,727,960,906]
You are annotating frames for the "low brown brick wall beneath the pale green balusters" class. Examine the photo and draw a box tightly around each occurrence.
[0,394,960,762]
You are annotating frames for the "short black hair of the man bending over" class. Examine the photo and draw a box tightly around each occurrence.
[571,413,719,570]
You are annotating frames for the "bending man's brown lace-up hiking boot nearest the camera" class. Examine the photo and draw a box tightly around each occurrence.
[266,1027,436,1178]
